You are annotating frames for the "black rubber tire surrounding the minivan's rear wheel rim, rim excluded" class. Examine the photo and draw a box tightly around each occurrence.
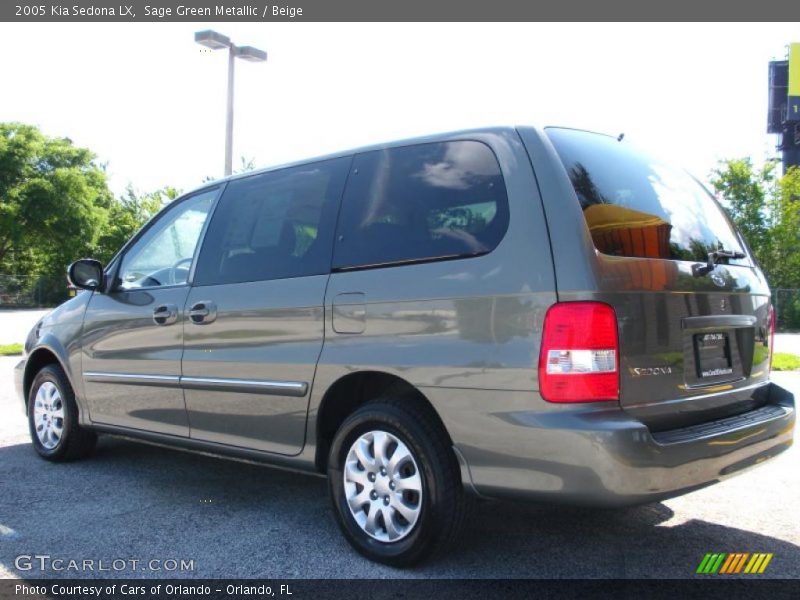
[328,398,466,566]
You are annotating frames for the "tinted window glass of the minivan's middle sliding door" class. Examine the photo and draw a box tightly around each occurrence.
[194,158,350,285]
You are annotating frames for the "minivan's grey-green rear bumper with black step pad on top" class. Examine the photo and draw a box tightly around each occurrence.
[456,383,795,506]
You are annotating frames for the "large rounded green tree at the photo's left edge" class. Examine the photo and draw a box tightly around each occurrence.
[0,123,113,274]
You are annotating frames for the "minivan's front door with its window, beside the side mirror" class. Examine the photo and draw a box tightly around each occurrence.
[82,189,219,437]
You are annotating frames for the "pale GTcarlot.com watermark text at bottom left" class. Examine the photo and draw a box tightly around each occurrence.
[14,554,194,574]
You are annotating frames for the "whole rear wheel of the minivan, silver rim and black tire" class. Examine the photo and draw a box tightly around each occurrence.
[328,398,465,566]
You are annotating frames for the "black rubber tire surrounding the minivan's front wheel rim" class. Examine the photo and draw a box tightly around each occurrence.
[28,364,97,462]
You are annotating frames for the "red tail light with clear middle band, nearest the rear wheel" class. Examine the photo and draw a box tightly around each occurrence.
[539,302,619,402]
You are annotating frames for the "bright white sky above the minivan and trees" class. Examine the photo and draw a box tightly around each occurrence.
[0,23,800,193]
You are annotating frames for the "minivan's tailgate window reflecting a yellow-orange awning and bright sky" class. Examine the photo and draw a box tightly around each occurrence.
[546,128,749,264]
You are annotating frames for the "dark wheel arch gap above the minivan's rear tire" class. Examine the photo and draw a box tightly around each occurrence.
[314,371,453,473]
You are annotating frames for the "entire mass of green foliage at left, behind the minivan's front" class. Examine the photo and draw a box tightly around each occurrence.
[0,123,179,303]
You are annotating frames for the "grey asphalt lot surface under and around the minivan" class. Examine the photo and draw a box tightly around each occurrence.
[0,312,800,578]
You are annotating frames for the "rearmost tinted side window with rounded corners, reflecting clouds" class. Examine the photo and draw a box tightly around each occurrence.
[333,141,508,269]
